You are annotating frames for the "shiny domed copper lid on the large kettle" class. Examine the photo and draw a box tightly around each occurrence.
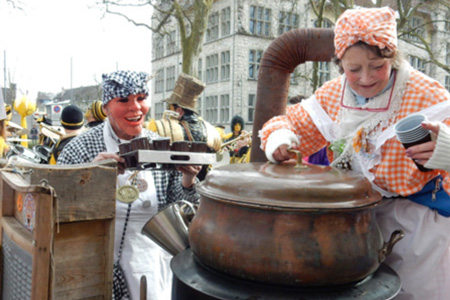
[197,162,381,210]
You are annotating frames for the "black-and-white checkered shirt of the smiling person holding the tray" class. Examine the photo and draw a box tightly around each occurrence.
[57,123,199,210]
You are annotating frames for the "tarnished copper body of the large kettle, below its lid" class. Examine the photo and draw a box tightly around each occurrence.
[189,196,383,286]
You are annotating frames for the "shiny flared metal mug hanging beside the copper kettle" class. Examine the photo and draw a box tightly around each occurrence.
[142,200,197,256]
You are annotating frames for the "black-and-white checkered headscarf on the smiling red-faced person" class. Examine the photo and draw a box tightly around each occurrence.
[102,71,151,105]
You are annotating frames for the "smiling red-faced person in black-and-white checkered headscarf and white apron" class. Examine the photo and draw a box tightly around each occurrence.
[58,71,200,300]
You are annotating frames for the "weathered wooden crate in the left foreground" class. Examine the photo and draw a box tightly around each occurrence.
[0,163,117,300]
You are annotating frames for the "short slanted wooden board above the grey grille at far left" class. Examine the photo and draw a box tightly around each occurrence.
[1,216,33,254]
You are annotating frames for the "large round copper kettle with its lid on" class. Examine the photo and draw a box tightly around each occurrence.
[189,162,402,286]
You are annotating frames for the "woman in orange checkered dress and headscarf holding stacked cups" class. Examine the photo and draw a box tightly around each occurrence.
[259,7,450,300]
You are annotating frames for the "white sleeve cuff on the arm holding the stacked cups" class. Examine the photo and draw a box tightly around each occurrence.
[424,122,450,172]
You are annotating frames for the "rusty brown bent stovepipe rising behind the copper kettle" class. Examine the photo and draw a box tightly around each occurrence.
[250,28,334,162]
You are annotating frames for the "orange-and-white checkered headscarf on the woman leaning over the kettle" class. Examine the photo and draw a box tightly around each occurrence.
[334,6,397,59]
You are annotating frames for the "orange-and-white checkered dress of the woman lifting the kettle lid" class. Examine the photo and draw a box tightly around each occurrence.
[260,69,450,196]
